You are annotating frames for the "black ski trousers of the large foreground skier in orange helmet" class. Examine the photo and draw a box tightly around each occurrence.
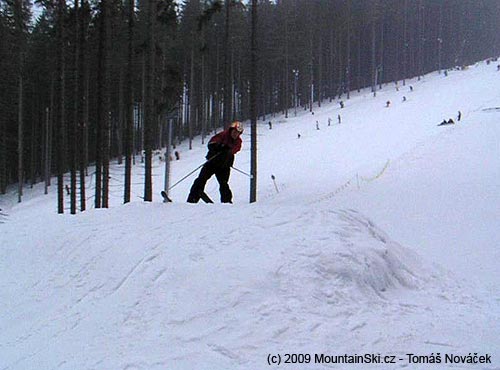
[187,162,233,203]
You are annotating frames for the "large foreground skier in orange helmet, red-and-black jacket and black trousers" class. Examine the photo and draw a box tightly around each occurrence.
[187,121,243,203]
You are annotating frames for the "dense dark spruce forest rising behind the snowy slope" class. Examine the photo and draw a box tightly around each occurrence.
[0,0,500,213]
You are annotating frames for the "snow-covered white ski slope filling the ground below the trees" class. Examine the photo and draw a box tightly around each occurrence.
[0,62,500,370]
